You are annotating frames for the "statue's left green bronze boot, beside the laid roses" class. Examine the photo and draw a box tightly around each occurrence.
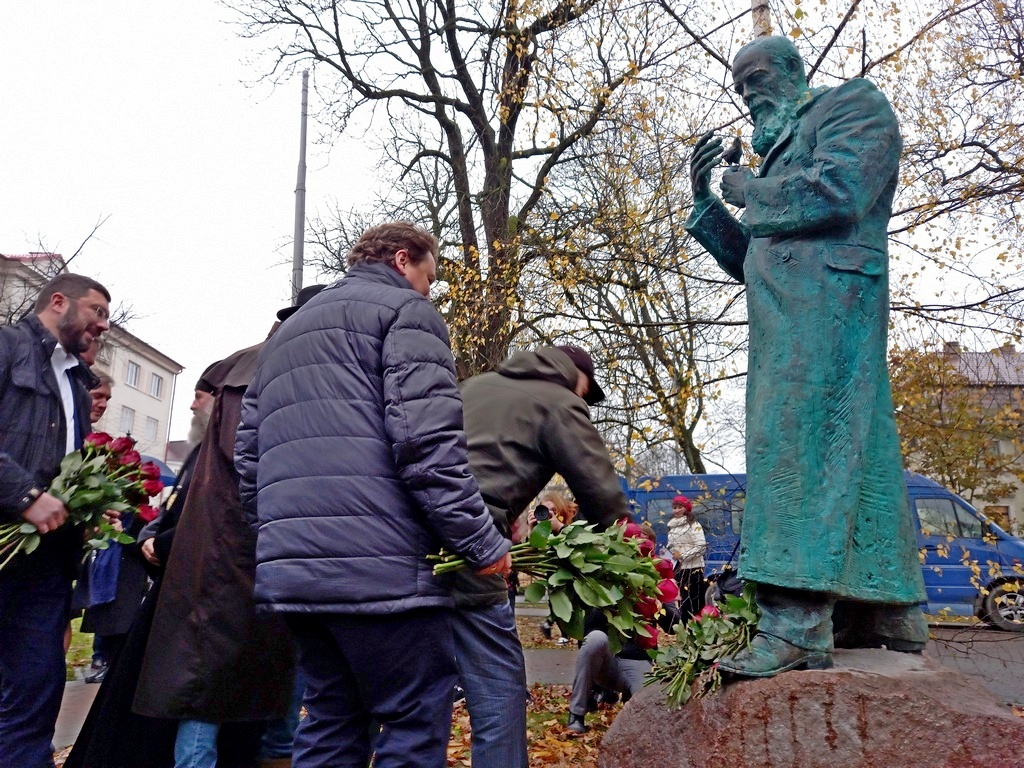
[718,584,836,677]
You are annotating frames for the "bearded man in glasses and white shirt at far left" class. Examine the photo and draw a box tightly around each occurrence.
[0,273,111,768]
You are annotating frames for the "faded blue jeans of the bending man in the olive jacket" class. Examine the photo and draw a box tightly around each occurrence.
[454,602,529,768]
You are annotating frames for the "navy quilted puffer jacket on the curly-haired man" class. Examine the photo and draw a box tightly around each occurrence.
[236,263,510,613]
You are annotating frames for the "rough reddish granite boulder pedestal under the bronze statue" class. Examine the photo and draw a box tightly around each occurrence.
[597,650,1024,768]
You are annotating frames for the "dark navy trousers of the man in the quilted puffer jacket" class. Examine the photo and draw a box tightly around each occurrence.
[286,608,457,768]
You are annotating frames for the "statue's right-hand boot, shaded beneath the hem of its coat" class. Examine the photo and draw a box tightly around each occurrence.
[836,602,928,653]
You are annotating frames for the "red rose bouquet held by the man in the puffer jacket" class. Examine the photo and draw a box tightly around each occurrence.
[431,520,679,652]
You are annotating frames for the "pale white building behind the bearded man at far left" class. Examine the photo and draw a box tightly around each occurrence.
[0,253,182,460]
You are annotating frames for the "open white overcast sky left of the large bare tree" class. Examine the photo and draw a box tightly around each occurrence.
[0,0,372,439]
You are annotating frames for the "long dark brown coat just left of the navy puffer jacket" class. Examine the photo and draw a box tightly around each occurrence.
[134,346,294,723]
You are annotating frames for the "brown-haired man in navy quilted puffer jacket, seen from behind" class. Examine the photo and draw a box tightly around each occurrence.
[236,222,510,768]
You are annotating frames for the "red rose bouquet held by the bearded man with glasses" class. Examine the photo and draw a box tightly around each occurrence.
[0,432,164,568]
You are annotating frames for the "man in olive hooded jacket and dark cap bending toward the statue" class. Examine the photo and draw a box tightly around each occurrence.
[455,346,629,768]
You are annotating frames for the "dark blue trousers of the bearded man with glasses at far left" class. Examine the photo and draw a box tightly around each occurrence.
[0,553,71,768]
